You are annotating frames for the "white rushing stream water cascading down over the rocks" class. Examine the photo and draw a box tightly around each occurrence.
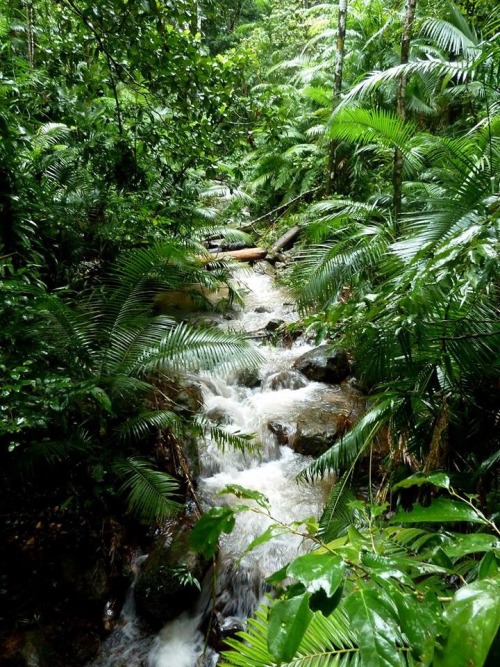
[93,273,344,667]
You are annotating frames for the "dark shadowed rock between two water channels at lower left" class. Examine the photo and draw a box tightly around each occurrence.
[134,525,207,630]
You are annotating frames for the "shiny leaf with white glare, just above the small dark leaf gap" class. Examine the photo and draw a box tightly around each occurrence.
[288,553,345,597]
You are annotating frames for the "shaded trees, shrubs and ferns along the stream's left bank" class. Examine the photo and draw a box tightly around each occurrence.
[0,0,264,523]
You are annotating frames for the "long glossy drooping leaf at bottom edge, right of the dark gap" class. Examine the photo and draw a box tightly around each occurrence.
[345,590,406,667]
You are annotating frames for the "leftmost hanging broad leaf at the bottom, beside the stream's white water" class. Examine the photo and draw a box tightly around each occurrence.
[267,593,313,663]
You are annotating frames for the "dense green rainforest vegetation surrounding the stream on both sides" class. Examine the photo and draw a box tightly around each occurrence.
[0,0,500,667]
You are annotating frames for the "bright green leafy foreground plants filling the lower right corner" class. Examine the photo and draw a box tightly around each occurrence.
[193,473,500,667]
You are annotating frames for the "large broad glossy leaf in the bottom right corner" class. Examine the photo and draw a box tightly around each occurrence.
[434,577,500,667]
